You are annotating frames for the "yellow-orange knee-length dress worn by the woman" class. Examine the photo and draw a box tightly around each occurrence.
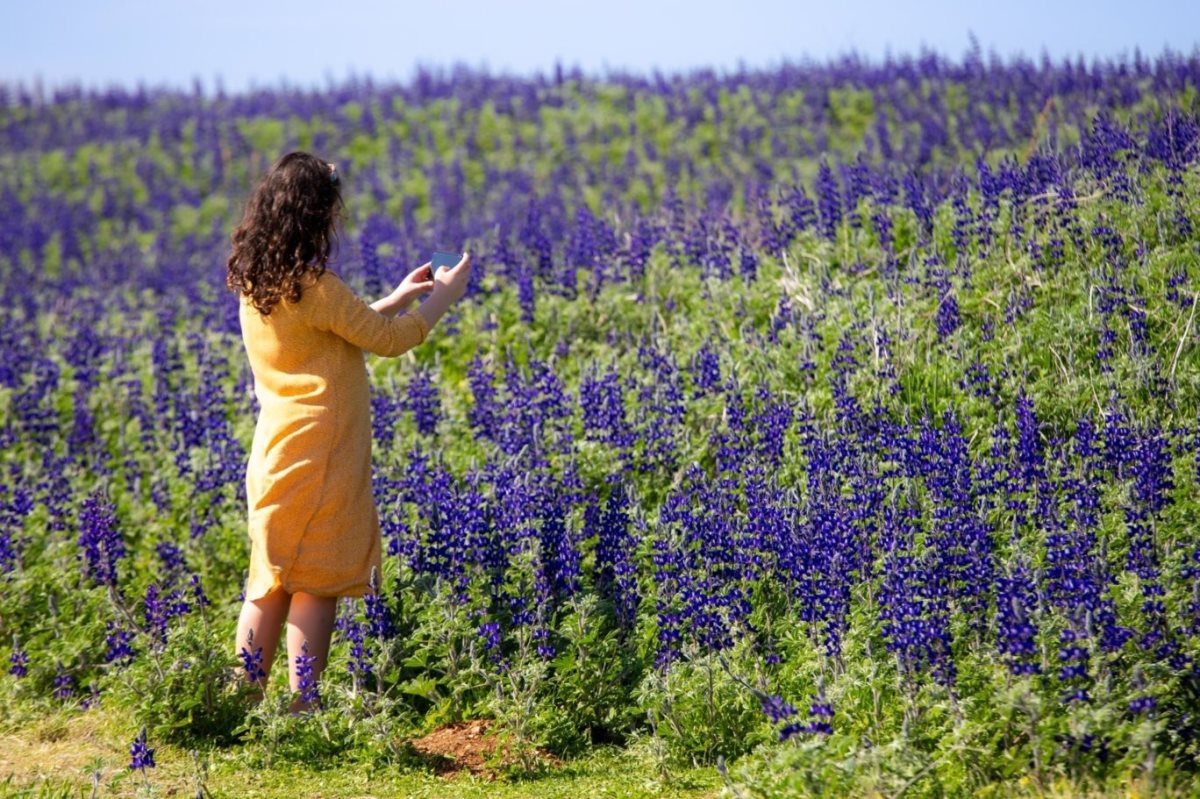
[239,271,430,600]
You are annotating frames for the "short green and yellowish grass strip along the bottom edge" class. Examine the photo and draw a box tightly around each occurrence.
[0,708,721,799]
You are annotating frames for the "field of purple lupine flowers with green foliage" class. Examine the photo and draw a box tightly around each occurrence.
[0,50,1200,797]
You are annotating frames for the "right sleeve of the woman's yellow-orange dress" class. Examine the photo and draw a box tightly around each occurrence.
[312,272,430,358]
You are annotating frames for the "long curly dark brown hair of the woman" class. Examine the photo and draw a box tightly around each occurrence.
[226,151,346,316]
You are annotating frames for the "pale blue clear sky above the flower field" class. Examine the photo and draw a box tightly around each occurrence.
[0,0,1200,94]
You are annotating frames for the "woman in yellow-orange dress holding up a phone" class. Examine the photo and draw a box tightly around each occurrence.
[227,152,470,713]
